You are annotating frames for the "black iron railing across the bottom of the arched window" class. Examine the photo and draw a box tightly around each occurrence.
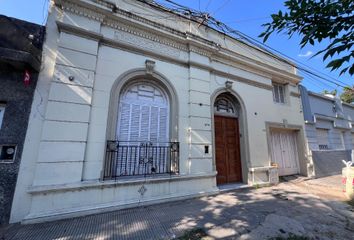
[104,141,179,179]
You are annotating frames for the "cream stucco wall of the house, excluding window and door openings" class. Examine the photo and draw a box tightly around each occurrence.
[12,1,305,222]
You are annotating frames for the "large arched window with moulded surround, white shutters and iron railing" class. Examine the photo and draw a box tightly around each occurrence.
[104,70,179,179]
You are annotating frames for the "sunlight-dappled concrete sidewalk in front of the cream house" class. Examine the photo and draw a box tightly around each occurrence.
[0,183,354,240]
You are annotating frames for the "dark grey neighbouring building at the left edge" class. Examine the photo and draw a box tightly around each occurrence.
[0,15,45,225]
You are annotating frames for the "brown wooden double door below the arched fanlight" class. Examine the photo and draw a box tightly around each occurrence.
[214,116,242,184]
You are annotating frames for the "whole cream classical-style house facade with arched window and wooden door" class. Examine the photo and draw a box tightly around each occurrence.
[11,0,311,222]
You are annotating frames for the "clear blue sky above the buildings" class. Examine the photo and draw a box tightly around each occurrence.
[0,0,354,92]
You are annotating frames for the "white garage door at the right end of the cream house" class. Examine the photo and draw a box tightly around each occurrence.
[271,130,299,176]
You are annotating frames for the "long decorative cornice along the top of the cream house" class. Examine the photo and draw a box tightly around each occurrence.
[55,0,301,83]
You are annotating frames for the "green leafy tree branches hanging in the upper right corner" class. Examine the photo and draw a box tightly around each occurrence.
[259,0,354,75]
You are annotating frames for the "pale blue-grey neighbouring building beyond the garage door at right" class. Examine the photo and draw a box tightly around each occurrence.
[301,86,354,177]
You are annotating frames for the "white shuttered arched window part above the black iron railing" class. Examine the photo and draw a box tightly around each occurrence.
[117,81,170,143]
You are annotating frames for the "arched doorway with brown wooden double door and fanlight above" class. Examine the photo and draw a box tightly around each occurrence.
[214,93,242,185]
